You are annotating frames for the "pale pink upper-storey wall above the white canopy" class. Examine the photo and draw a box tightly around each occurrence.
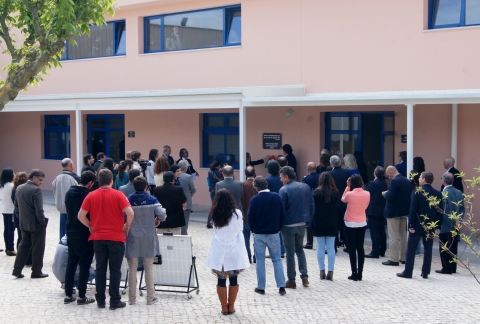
[0,0,480,95]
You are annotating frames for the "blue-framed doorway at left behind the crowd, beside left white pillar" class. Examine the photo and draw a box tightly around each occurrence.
[87,115,125,163]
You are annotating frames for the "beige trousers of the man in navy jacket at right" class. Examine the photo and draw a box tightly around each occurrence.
[387,216,407,262]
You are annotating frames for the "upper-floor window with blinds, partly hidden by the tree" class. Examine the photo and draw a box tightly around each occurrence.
[62,21,127,60]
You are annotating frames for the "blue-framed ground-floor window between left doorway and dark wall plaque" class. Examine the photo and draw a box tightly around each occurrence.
[202,114,240,168]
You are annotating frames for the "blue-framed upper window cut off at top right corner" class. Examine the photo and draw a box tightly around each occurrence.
[430,0,480,28]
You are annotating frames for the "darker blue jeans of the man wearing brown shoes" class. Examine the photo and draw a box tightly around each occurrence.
[282,226,308,283]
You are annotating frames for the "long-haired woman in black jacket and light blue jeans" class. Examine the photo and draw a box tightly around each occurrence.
[312,172,340,280]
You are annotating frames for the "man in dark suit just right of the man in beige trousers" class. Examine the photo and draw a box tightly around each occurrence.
[397,172,443,279]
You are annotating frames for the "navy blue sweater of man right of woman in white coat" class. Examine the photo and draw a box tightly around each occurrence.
[247,192,286,234]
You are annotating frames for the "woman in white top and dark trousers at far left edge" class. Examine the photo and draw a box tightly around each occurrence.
[0,168,17,256]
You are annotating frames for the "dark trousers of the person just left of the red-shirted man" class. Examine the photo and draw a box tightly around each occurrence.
[65,235,93,298]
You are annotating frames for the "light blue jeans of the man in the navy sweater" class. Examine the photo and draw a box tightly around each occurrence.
[253,234,285,290]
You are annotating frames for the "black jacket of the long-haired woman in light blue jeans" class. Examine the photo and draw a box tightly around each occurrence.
[311,190,340,237]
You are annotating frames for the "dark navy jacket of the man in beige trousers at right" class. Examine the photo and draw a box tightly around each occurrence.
[385,174,412,218]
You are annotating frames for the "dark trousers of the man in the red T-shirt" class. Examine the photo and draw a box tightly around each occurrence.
[93,241,125,305]
